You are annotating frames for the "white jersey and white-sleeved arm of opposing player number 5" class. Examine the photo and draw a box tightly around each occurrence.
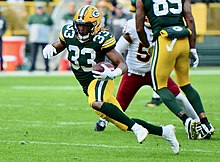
[116,19,152,76]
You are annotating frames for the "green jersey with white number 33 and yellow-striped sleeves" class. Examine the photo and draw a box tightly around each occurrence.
[59,24,116,95]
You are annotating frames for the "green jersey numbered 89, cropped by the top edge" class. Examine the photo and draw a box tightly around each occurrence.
[142,0,184,40]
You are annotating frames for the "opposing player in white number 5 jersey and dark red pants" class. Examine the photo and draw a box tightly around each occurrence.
[95,19,203,139]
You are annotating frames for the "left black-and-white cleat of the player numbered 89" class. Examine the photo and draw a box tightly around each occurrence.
[185,117,199,140]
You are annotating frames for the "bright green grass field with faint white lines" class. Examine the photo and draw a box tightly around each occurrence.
[0,68,220,162]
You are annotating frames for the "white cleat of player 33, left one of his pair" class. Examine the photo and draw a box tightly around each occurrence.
[131,123,149,144]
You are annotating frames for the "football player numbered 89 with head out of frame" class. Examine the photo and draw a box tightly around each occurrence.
[135,0,214,138]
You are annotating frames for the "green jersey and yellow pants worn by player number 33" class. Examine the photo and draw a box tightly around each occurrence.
[59,25,127,130]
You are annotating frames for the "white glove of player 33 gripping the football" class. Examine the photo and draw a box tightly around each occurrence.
[92,64,122,80]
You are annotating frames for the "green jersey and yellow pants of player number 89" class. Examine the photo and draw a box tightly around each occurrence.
[142,0,191,90]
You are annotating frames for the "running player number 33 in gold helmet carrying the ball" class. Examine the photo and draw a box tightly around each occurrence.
[43,5,179,154]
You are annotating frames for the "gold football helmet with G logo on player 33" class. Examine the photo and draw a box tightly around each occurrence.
[73,5,101,39]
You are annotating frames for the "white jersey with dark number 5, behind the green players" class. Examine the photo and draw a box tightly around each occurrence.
[119,19,153,75]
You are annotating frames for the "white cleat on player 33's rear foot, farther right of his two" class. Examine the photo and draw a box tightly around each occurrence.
[162,124,179,154]
